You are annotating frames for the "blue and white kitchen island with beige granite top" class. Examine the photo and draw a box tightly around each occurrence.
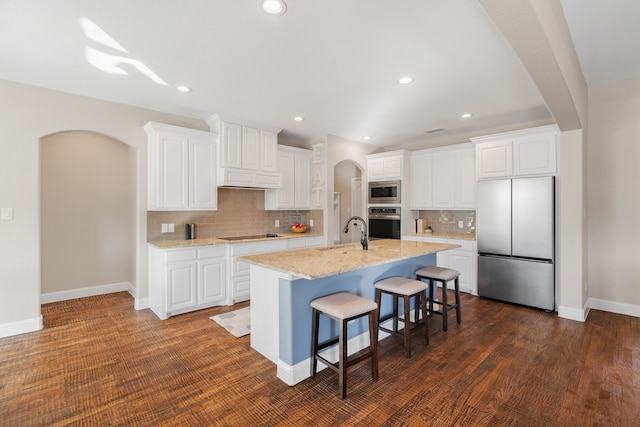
[241,239,459,385]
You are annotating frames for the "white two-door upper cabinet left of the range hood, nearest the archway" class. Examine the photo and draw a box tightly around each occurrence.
[144,122,217,210]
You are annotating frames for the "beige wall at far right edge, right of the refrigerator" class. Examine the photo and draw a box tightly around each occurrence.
[587,78,640,306]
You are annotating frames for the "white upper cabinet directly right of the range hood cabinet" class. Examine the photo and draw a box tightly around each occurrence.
[264,145,313,210]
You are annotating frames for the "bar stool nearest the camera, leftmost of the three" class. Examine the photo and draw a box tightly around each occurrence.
[311,292,378,399]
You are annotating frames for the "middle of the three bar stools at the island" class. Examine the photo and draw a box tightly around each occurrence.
[374,276,429,357]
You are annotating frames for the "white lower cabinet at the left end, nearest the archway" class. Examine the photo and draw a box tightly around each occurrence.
[149,245,227,319]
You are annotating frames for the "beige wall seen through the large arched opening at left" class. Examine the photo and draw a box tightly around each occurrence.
[40,132,136,293]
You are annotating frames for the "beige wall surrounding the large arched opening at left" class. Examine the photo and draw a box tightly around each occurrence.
[0,80,208,329]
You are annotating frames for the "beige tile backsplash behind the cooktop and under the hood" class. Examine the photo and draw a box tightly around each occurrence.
[147,188,323,242]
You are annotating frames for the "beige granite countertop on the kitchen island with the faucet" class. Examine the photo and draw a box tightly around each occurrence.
[239,239,460,280]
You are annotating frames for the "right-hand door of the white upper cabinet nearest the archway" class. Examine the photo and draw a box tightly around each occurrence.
[189,137,218,210]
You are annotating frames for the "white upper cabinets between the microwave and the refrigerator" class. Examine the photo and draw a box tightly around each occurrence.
[409,144,476,210]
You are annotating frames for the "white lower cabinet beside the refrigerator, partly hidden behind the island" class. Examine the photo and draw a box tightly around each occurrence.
[402,235,478,295]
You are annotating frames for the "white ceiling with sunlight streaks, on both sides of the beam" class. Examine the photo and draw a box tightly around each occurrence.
[0,0,640,146]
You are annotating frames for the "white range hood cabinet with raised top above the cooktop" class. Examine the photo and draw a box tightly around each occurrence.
[207,115,282,188]
